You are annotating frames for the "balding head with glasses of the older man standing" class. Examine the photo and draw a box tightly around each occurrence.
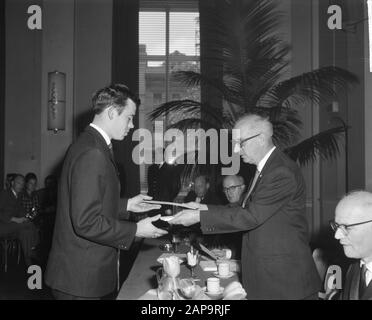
[233,114,274,165]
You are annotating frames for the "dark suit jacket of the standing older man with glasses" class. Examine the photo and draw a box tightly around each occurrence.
[200,149,321,299]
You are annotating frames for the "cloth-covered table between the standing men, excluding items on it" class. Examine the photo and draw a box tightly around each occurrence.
[117,238,239,300]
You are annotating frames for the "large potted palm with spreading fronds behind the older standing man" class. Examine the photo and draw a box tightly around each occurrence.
[150,0,358,180]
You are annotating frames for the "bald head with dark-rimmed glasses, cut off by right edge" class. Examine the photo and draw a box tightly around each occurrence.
[335,191,372,263]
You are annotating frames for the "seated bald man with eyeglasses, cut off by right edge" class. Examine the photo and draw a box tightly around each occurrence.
[331,191,372,300]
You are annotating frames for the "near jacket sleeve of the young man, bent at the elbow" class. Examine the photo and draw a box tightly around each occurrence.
[70,149,137,249]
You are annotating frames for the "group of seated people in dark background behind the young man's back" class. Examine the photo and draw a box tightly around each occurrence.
[0,172,57,267]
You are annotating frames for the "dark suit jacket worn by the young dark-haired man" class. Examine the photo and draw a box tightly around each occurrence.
[46,127,137,297]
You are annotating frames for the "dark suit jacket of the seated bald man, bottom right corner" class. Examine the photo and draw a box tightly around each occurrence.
[341,260,372,300]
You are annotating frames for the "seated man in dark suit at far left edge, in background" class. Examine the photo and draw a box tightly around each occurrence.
[0,175,39,266]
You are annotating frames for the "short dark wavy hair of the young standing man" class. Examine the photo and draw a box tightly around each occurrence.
[92,83,141,114]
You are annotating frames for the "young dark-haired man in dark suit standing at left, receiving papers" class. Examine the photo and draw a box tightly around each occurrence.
[46,85,167,300]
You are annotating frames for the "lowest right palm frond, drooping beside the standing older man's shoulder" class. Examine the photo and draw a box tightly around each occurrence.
[284,126,345,165]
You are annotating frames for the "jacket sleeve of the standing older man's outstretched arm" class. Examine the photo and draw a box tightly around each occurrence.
[200,168,297,233]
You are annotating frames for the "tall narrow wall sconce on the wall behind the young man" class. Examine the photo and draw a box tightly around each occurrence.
[48,71,66,133]
